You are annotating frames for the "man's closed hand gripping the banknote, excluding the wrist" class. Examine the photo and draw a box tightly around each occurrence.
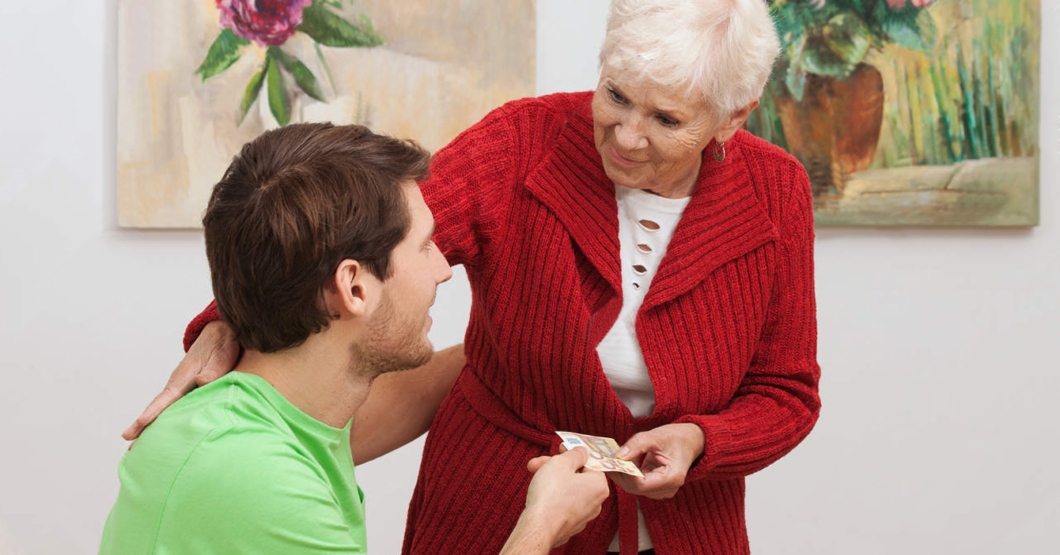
[525,448,611,548]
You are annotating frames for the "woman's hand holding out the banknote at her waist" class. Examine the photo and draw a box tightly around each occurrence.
[607,424,705,499]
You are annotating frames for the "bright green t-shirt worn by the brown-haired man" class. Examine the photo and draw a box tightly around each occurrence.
[100,372,367,555]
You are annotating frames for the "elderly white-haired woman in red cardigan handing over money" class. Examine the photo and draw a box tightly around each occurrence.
[130,0,819,555]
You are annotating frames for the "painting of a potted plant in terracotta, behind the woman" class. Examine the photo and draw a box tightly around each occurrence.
[747,0,1041,227]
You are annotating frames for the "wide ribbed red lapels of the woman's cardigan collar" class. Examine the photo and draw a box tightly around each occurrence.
[526,94,777,310]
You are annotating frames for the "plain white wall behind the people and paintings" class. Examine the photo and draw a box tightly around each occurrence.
[0,0,1060,555]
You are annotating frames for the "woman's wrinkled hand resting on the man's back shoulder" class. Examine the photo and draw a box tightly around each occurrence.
[122,320,240,441]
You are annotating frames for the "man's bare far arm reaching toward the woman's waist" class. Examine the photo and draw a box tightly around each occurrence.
[350,343,464,465]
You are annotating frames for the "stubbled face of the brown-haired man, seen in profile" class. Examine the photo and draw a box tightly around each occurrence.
[360,182,453,374]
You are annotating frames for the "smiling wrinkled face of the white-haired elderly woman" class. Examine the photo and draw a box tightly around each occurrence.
[593,65,720,198]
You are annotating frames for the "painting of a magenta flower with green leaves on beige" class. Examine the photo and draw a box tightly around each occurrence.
[118,0,536,228]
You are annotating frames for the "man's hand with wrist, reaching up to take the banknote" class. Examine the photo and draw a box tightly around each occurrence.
[500,448,611,555]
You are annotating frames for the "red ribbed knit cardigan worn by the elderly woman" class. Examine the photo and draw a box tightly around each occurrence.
[188,92,819,555]
